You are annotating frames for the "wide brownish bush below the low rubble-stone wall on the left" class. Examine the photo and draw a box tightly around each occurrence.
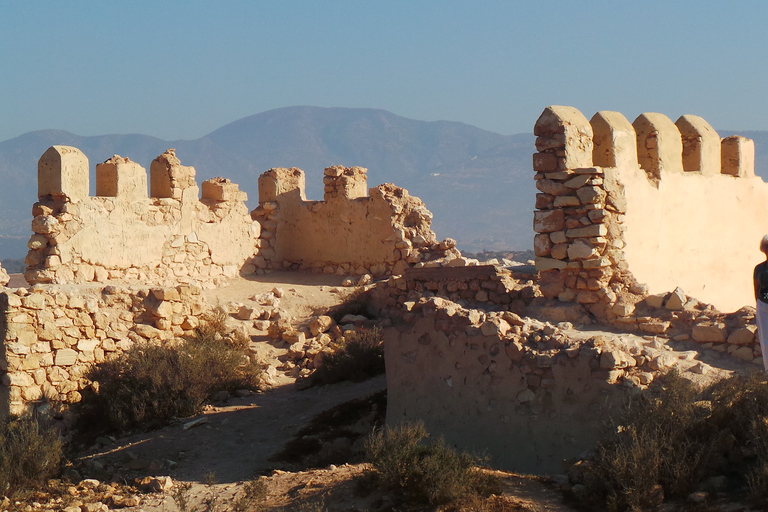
[81,319,261,431]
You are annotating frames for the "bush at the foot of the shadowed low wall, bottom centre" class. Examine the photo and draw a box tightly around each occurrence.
[367,423,499,505]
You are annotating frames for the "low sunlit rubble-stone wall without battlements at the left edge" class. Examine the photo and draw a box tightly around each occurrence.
[0,284,208,417]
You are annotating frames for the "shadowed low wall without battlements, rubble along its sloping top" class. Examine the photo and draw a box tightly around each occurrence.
[384,298,674,474]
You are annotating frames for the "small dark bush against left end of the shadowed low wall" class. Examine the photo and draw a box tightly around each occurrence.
[310,328,384,386]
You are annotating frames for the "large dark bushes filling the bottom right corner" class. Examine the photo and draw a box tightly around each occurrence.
[578,372,768,511]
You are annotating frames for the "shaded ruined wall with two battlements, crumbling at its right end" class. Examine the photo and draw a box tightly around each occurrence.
[251,166,460,275]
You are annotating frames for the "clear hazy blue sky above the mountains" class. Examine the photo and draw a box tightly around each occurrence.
[0,0,768,140]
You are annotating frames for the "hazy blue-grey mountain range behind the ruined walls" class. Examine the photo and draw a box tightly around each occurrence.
[0,106,768,259]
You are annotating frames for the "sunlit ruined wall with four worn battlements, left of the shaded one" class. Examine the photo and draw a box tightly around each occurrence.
[25,146,260,286]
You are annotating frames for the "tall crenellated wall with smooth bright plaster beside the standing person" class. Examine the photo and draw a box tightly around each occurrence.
[533,106,768,319]
